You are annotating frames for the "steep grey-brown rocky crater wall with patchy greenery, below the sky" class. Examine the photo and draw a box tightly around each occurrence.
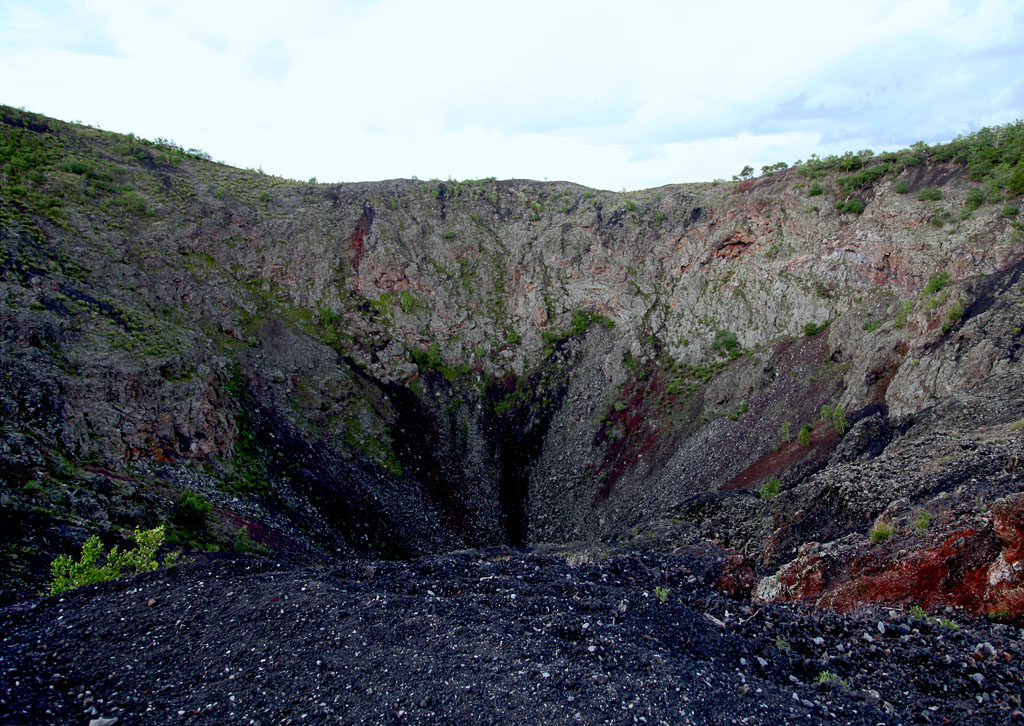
[0,110,1024,609]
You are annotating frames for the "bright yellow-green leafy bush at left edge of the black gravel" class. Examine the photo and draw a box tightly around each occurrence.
[50,524,179,595]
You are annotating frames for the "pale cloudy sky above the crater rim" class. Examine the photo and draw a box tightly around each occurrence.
[0,0,1024,190]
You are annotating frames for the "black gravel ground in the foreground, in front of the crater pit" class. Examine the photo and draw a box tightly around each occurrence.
[0,550,1024,726]
